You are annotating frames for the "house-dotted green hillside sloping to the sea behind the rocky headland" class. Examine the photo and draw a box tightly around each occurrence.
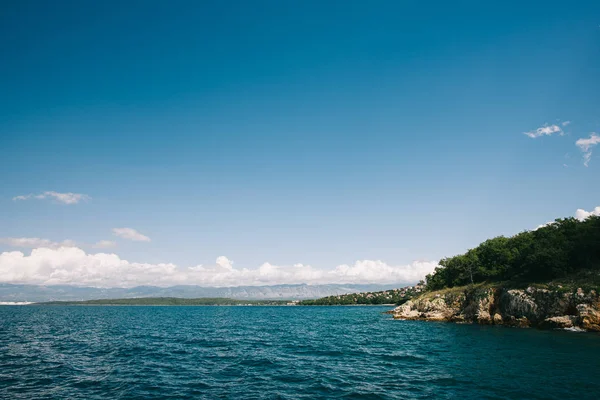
[298,285,424,306]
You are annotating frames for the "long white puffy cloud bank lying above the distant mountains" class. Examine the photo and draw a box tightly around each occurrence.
[0,247,437,287]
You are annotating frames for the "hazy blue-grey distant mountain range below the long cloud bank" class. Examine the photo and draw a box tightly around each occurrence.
[0,283,404,302]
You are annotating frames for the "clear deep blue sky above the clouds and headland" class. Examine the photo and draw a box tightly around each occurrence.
[0,0,600,288]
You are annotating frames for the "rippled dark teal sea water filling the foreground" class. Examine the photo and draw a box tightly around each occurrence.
[0,306,600,399]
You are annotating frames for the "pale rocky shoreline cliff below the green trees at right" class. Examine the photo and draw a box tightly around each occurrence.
[392,286,600,332]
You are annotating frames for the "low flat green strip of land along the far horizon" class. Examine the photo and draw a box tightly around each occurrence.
[37,297,287,306]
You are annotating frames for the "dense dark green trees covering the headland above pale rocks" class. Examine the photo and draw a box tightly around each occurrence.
[426,216,600,290]
